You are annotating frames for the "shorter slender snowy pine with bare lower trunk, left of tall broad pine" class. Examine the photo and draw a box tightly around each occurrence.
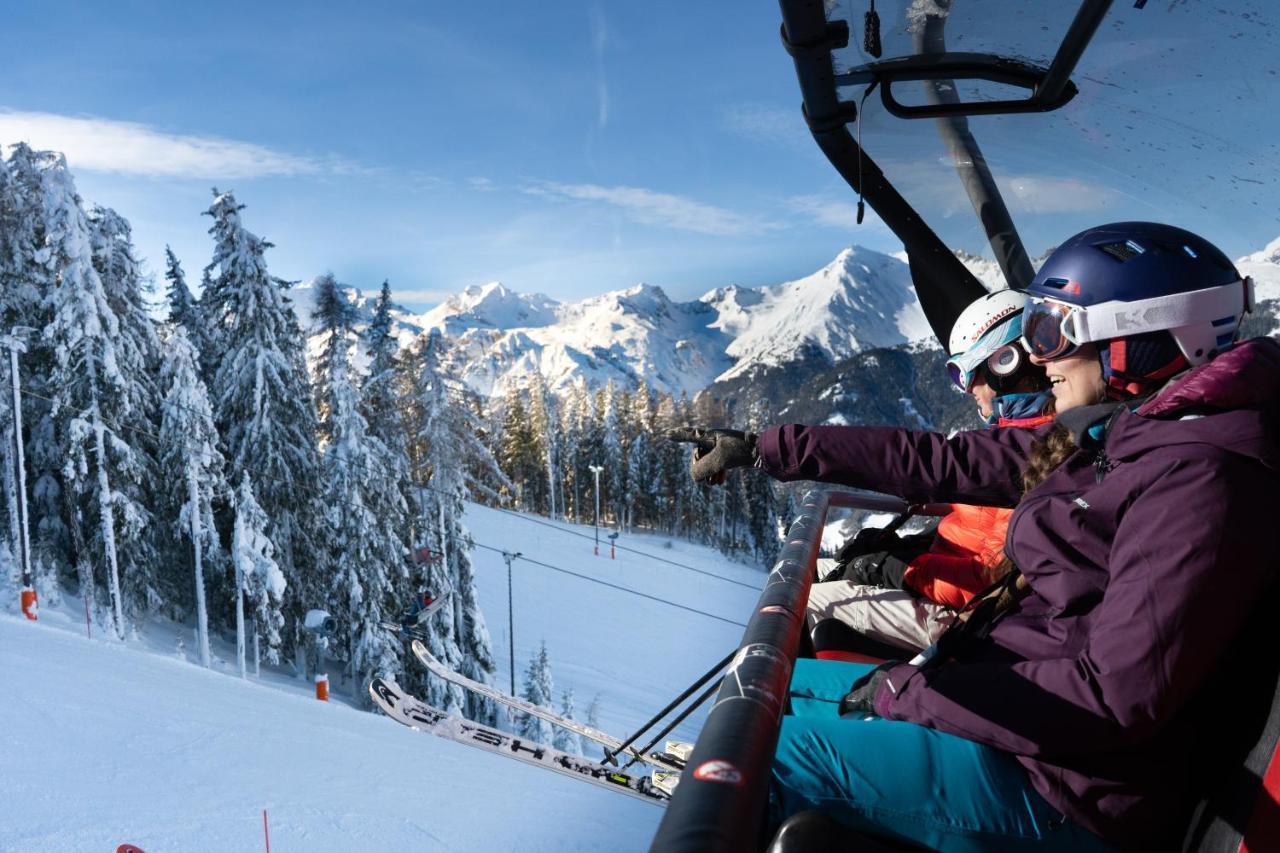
[157,325,227,666]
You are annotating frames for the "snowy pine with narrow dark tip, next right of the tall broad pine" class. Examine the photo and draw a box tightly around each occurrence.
[316,275,408,698]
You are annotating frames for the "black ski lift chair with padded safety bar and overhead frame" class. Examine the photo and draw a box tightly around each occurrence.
[652,0,1280,853]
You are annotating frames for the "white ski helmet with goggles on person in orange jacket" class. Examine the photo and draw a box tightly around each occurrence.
[947,289,1029,392]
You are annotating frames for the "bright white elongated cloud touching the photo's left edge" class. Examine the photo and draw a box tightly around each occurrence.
[0,109,366,179]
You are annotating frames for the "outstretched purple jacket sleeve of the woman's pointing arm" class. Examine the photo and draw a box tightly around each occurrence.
[756,424,1048,506]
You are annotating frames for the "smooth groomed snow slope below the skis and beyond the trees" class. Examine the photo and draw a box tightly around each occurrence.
[0,507,764,853]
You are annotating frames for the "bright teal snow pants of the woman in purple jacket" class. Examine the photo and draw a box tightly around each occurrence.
[771,658,1111,853]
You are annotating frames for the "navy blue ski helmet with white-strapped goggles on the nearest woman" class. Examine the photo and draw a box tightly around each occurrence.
[1023,222,1253,397]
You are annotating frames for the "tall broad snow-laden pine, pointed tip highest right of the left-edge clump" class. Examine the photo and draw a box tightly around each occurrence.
[201,190,332,660]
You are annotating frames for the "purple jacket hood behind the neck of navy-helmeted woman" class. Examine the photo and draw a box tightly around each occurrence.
[1106,338,1280,470]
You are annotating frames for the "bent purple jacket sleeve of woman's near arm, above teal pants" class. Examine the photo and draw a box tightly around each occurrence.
[876,453,1276,758]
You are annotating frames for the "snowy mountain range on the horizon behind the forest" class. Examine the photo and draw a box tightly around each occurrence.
[293,238,1280,397]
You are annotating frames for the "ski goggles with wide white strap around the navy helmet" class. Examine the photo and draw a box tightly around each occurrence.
[1023,277,1254,361]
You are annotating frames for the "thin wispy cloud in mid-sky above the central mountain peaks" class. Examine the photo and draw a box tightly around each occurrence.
[522,182,778,237]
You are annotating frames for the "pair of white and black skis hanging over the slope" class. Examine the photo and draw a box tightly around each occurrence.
[369,625,692,804]
